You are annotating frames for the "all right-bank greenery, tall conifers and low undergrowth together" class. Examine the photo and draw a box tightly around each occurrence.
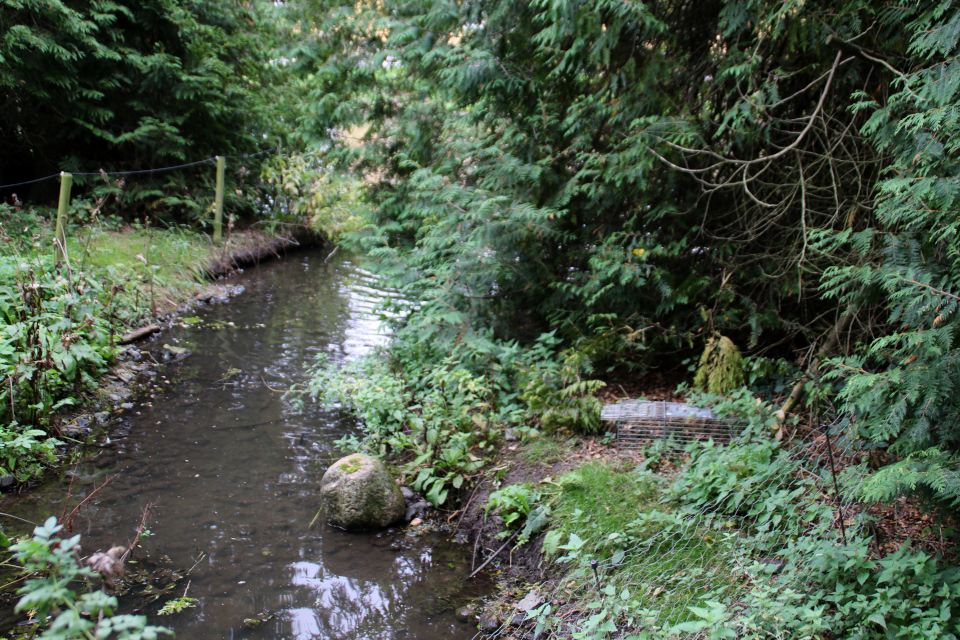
[300,0,960,638]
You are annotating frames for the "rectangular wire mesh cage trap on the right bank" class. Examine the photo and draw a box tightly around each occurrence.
[600,400,746,449]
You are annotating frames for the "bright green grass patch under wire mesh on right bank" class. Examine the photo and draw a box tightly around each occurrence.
[539,462,738,637]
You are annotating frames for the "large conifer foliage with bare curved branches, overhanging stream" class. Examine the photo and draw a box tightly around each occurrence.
[298,0,904,365]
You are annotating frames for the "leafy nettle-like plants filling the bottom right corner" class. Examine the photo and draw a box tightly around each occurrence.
[688,536,960,640]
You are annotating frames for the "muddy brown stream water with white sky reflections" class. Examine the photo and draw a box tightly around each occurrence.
[3,253,488,640]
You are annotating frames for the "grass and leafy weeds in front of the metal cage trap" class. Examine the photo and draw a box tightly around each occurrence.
[489,412,960,640]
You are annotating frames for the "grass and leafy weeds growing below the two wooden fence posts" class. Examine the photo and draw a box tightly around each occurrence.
[0,205,296,482]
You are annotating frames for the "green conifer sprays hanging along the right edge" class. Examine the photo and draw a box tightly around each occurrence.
[820,2,960,510]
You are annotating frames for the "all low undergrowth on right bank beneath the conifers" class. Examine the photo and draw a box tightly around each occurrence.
[309,328,960,640]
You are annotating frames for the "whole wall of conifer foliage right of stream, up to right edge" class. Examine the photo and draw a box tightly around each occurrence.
[298,0,960,512]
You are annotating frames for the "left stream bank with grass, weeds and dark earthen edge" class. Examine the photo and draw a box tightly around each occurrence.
[0,226,324,490]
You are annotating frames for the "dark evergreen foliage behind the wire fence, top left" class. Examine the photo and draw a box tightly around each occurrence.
[0,0,295,220]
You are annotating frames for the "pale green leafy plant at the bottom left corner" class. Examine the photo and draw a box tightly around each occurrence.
[10,517,172,640]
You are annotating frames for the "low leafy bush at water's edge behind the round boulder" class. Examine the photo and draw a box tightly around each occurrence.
[296,327,602,505]
